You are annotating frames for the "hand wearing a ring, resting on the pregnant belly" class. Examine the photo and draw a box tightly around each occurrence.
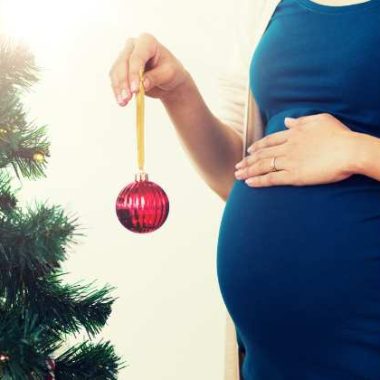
[235,113,355,187]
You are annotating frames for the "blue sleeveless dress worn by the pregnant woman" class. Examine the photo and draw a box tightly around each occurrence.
[216,0,380,380]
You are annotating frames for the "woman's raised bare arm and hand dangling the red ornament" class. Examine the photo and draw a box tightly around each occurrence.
[109,33,243,200]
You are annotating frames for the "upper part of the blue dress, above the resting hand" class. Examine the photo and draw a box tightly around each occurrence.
[250,0,380,137]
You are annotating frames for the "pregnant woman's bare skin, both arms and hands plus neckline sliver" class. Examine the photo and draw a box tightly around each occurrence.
[109,25,380,201]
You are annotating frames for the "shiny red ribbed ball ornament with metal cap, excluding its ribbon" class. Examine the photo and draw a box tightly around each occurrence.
[116,173,169,233]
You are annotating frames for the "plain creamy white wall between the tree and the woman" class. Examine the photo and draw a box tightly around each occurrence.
[1,0,238,380]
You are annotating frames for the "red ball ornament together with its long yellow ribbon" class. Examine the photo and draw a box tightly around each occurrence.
[116,70,169,233]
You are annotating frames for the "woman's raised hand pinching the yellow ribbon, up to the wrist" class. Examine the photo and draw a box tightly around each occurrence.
[109,33,189,106]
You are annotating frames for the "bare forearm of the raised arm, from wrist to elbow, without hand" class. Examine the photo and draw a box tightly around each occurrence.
[161,73,243,200]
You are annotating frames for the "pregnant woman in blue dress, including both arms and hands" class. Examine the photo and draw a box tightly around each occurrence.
[110,0,380,380]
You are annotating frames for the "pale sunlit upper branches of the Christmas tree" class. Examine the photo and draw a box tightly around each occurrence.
[0,36,49,179]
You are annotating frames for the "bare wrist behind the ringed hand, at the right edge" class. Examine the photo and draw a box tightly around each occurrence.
[350,132,380,181]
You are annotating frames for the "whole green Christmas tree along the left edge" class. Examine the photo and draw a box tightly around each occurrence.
[0,35,122,380]
